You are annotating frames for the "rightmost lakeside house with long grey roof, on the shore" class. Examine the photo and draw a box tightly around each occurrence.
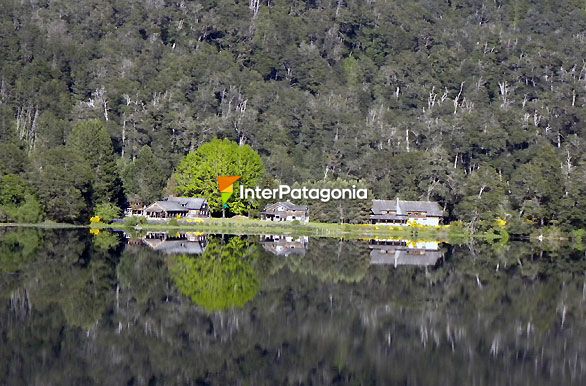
[370,198,444,225]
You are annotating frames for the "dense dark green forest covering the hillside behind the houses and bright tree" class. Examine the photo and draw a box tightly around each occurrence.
[0,0,586,232]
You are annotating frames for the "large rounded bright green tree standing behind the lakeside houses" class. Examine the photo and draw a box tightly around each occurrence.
[175,139,265,214]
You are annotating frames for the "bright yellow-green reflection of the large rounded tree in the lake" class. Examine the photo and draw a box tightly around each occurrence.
[169,237,259,311]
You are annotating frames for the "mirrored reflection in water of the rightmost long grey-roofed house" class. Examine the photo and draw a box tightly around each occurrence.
[370,240,443,267]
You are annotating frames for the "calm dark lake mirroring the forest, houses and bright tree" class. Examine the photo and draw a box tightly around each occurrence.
[0,228,586,386]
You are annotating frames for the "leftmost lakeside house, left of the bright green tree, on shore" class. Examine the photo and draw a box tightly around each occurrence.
[143,197,210,219]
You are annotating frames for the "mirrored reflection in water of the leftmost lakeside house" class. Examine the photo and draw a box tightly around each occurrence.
[142,232,208,255]
